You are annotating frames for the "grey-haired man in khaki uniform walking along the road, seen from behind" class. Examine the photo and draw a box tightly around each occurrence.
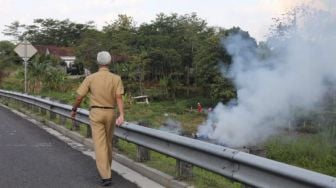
[71,51,124,186]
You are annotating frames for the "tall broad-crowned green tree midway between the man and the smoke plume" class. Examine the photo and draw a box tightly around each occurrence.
[137,13,207,94]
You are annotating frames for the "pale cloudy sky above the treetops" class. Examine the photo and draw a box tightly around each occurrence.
[0,0,326,41]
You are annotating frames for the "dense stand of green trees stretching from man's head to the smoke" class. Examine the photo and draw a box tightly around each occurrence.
[71,13,256,101]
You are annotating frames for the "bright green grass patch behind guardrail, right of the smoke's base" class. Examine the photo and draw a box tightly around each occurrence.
[265,132,336,176]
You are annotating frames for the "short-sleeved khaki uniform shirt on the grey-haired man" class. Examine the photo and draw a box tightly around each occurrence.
[77,67,124,107]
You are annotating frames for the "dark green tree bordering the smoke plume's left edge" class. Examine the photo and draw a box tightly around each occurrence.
[195,28,242,102]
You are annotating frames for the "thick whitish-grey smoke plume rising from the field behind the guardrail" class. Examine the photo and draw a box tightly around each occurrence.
[198,1,336,147]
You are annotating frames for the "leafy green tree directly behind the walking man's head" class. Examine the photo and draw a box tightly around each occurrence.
[76,15,137,73]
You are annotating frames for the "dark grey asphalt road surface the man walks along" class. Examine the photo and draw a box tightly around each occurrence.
[0,106,137,188]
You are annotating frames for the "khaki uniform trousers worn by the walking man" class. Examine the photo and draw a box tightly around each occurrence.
[89,108,115,179]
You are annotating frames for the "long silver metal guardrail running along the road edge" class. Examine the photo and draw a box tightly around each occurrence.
[0,90,336,188]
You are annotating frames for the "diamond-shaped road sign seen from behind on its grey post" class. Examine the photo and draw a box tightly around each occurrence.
[14,40,37,93]
